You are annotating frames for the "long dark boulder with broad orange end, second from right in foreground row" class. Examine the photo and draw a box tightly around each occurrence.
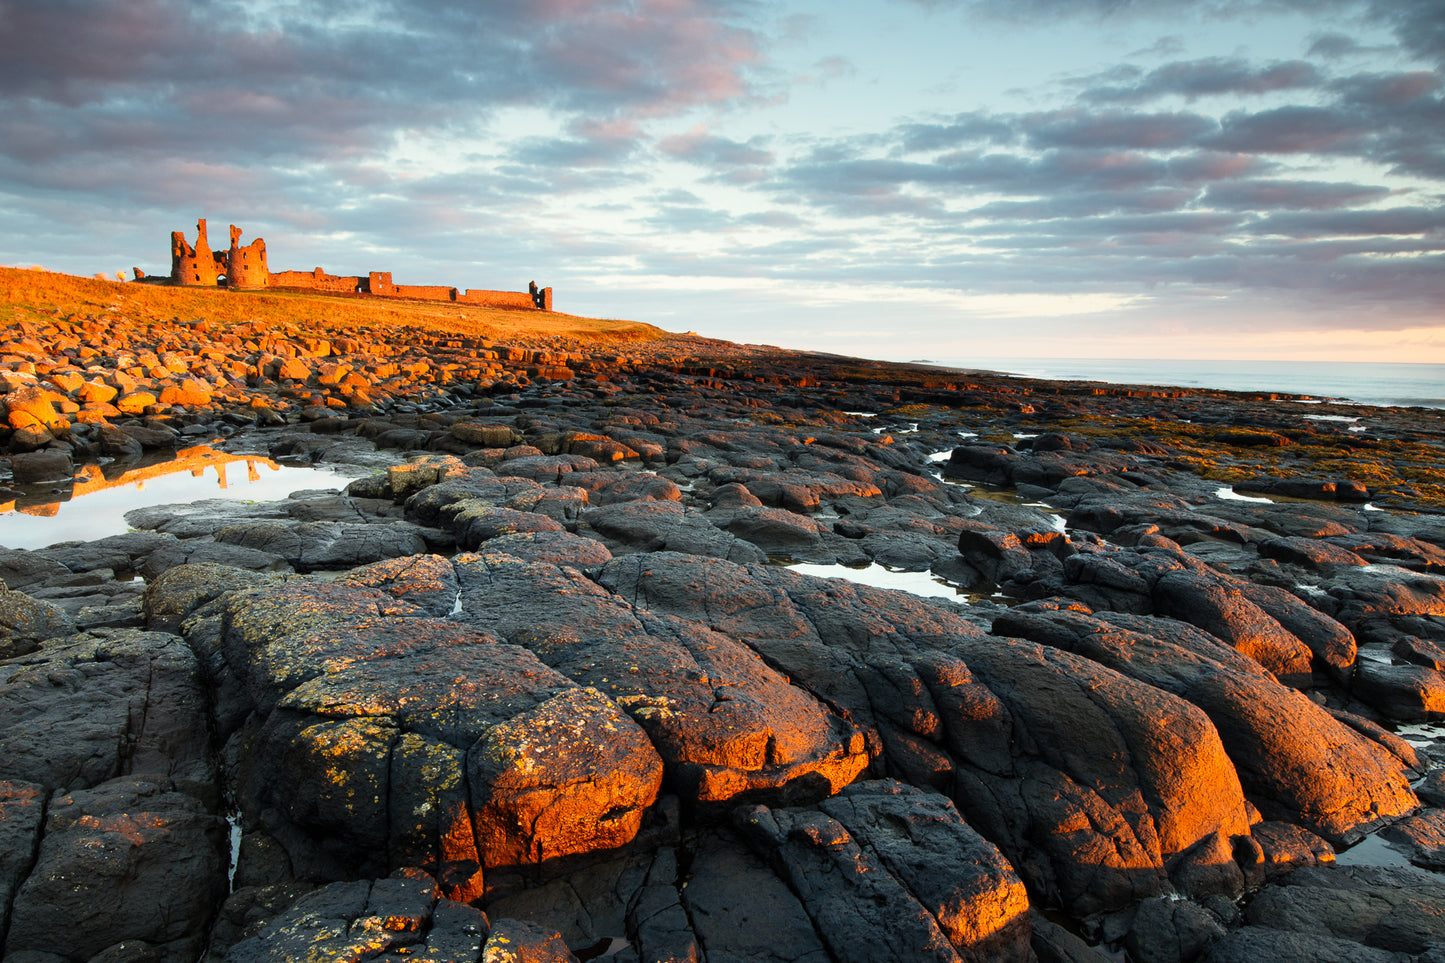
[600,554,1248,915]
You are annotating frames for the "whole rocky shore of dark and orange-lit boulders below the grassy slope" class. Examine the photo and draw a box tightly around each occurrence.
[0,271,1445,963]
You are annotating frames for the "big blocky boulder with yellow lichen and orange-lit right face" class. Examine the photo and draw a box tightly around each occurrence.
[210,571,662,892]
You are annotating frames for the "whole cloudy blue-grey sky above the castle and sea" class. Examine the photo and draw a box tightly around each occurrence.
[0,0,1445,363]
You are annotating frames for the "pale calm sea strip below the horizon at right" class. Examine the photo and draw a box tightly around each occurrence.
[899,357,1445,408]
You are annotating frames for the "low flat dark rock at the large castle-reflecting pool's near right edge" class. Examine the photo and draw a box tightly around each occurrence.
[215,521,426,571]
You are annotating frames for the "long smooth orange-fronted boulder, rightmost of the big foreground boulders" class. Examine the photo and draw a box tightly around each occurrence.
[993,610,1416,842]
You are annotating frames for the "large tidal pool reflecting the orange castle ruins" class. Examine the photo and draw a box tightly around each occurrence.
[0,445,351,548]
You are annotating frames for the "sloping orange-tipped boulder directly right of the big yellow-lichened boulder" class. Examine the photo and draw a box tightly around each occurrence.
[454,555,868,803]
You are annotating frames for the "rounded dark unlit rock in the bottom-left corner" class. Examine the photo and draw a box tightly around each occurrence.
[6,776,225,963]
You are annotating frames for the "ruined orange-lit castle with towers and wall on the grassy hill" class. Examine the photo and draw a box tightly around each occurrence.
[153,218,552,311]
